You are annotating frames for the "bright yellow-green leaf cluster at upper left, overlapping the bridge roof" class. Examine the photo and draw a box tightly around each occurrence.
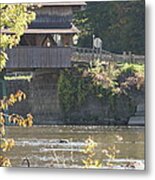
[0,4,35,71]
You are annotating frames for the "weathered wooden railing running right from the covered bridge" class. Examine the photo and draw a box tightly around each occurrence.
[71,47,145,63]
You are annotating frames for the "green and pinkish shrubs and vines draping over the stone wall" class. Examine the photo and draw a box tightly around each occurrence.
[58,60,144,114]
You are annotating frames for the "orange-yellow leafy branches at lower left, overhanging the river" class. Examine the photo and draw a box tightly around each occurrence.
[0,91,33,167]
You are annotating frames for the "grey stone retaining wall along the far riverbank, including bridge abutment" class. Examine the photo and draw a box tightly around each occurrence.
[7,69,144,125]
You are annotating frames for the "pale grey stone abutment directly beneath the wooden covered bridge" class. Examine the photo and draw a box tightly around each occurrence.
[30,70,61,124]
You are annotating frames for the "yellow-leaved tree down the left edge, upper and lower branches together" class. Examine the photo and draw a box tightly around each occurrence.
[0,4,35,166]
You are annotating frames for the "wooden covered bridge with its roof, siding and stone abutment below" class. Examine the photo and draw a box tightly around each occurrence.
[0,1,86,124]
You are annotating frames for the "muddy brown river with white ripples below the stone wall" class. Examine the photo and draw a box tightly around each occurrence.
[6,126,144,169]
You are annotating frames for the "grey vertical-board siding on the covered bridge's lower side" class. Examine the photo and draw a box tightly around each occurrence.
[6,47,72,69]
